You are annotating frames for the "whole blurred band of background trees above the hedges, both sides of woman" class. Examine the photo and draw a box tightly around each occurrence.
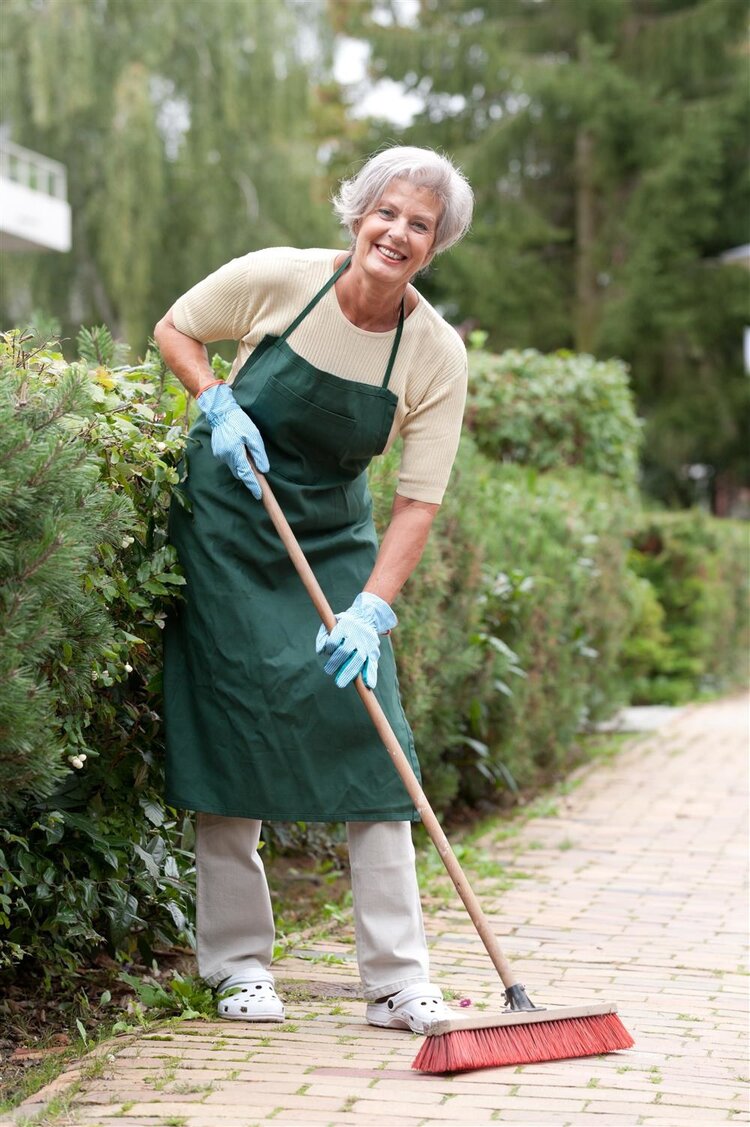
[0,0,750,512]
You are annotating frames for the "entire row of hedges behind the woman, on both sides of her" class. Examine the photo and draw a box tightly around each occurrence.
[0,329,748,988]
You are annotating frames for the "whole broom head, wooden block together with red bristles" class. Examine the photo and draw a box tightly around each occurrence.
[412,1003,633,1073]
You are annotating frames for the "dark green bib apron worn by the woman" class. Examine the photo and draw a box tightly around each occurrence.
[165,259,418,822]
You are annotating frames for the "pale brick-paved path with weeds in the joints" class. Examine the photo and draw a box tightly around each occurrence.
[7,696,750,1127]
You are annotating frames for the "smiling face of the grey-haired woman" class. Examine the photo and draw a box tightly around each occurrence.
[352,180,442,286]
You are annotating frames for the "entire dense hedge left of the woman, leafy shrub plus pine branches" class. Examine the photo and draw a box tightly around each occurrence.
[0,330,192,980]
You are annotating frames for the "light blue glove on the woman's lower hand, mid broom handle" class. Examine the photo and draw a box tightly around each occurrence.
[315,591,398,689]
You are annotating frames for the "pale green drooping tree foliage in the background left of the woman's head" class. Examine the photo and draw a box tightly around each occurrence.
[0,0,339,352]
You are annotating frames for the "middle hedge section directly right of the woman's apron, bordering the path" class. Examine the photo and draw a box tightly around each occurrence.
[371,435,634,810]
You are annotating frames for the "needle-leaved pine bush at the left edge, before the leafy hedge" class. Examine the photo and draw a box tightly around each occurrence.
[0,336,131,809]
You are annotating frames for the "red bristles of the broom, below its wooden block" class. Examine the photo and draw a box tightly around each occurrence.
[412,1013,634,1072]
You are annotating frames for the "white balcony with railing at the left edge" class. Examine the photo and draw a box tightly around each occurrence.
[0,140,71,251]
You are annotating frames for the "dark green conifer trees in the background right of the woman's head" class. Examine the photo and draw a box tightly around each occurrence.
[332,0,750,500]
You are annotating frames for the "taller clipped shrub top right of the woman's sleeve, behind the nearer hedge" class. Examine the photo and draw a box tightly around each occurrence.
[466,349,641,497]
